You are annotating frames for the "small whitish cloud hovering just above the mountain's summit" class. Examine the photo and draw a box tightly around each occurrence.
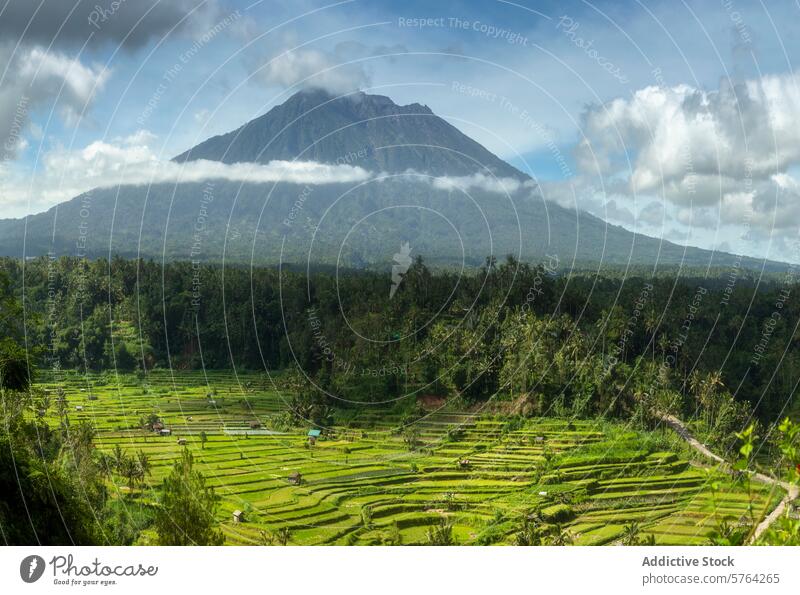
[258,49,369,95]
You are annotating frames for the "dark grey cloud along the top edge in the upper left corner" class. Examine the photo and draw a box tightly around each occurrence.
[0,0,220,48]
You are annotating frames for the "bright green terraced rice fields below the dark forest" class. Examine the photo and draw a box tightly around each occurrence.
[34,372,781,545]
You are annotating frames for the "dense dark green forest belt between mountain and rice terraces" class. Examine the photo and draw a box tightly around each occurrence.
[0,258,800,434]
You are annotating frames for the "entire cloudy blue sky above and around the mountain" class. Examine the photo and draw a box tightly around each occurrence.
[0,0,800,262]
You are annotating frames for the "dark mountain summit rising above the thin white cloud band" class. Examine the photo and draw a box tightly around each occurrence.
[175,89,527,179]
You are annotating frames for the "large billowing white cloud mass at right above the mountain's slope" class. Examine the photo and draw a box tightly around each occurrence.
[576,73,800,233]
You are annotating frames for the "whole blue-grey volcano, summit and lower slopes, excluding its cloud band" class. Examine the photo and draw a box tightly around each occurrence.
[0,91,779,268]
